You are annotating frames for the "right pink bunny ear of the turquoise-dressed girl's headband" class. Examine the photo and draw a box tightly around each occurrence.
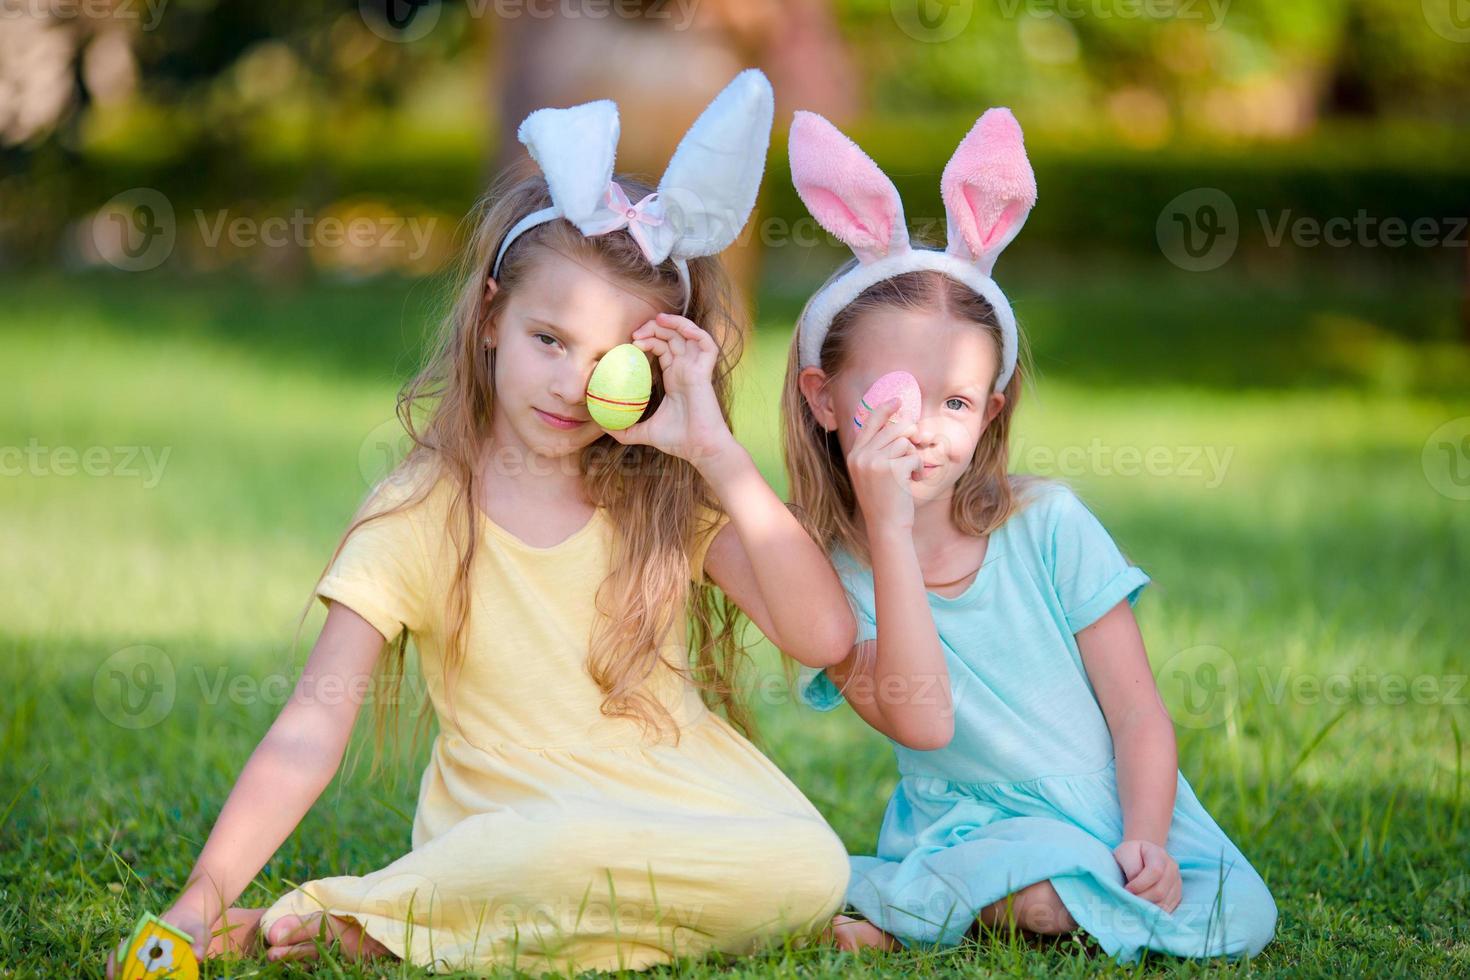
[941,109,1036,257]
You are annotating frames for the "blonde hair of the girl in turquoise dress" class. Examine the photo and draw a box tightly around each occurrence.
[781,259,1036,561]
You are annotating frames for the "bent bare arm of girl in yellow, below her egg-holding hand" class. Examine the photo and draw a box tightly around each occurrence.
[700,438,857,667]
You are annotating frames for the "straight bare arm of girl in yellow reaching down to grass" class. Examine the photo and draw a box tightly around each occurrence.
[155,602,384,952]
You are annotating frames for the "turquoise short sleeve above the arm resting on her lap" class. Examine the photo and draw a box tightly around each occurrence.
[1048,486,1150,633]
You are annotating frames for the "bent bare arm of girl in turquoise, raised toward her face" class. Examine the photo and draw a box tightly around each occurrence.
[828,526,954,751]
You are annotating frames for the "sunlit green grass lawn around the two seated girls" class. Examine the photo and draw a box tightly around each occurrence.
[0,264,1470,977]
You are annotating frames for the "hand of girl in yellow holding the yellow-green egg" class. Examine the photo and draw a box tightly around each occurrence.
[588,313,738,466]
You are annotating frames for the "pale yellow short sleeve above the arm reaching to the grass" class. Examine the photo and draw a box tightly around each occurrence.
[316,478,428,642]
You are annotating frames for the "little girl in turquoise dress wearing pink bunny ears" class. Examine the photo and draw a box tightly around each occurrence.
[782,109,1276,962]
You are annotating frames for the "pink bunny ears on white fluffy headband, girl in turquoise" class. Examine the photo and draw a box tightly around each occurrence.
[789,109,1036,391]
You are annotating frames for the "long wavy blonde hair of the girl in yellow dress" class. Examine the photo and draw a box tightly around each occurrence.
[303,175,756,774]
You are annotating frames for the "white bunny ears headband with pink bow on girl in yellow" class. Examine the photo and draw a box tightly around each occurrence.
[490,68,775,310]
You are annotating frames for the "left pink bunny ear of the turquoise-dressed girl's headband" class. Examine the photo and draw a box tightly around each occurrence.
[789,112,903,256]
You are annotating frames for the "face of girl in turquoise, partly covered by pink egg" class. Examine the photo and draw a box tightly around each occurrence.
[798,309,1005,500]
